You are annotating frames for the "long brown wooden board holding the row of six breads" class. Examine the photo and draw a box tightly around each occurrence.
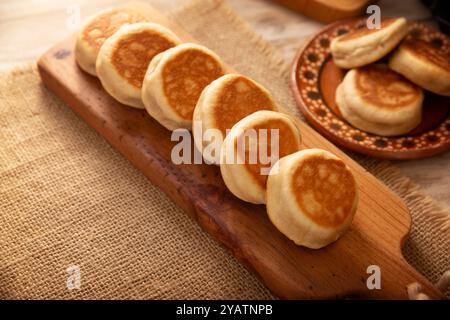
[38,4,442,299]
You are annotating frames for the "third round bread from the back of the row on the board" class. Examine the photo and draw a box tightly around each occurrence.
[142,43,226,130]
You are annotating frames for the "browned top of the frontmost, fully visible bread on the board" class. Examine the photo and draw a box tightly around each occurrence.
[292,156,356,227]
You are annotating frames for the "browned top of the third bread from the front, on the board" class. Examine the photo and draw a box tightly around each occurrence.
[213,77,274,135]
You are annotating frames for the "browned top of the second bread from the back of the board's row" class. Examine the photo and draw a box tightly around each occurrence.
[111,30,176,88]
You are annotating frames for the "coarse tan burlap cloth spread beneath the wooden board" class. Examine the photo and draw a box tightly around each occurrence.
[0,0,450,299]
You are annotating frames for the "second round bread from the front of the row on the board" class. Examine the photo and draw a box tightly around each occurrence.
[220,111,301,203]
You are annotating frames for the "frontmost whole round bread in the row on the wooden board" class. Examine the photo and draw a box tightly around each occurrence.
[266,149,358,249]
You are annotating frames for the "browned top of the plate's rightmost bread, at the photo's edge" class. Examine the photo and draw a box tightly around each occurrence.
[401,39,450,72]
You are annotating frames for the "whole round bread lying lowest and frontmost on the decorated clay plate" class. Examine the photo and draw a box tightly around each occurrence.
[336,64,423,136]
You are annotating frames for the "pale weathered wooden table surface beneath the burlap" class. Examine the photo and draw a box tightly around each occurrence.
[0,0,450,211]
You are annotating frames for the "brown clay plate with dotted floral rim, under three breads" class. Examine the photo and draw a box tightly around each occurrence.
[291,19,450,159]
